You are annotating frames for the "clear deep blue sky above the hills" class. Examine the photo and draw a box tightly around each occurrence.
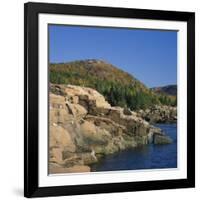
[49,25,177,87]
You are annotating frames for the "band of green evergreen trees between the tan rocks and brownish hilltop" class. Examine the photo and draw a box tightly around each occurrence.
[50,70,177,110]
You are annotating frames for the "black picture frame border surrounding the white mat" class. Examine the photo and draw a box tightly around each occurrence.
[24,2,195,197]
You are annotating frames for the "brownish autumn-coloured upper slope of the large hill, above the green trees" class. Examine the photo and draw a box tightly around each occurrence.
[50,59,145,89]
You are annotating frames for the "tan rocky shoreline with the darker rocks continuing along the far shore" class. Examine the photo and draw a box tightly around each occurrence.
[49,84,175,174]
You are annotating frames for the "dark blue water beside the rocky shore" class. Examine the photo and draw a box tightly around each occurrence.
[91,124,177,171]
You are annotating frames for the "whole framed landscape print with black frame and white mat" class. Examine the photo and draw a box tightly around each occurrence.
[24,3,195,197]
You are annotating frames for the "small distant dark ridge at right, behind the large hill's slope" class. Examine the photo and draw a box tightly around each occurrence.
[151,85,177,96]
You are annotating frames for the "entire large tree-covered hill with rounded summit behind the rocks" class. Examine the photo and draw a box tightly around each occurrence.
[49,59,176,110]
